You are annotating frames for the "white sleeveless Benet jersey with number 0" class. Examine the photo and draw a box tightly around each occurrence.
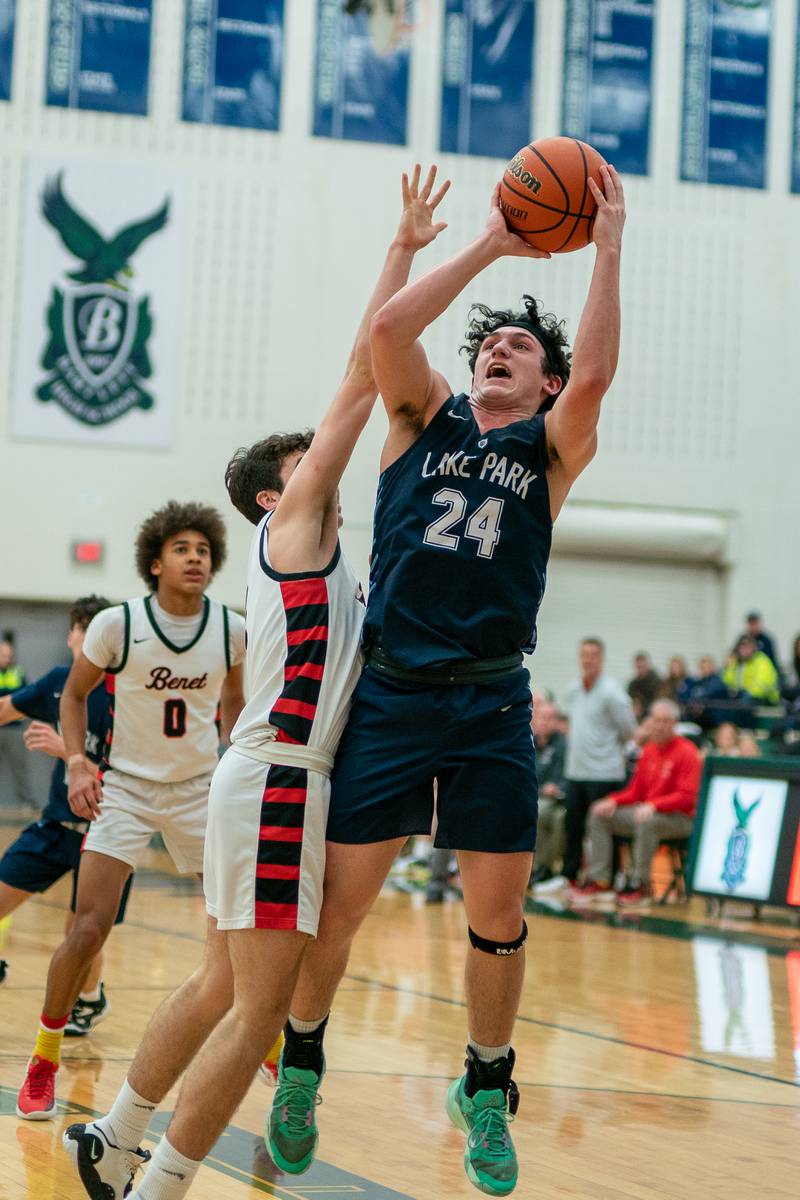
[103,596,230,784]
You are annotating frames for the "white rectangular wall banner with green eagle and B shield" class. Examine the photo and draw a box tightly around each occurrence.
[12,158,182,446]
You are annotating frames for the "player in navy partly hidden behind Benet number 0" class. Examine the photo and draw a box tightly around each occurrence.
[0,595,130,1017]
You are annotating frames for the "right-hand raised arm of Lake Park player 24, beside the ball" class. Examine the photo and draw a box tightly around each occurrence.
[546,167,625,516]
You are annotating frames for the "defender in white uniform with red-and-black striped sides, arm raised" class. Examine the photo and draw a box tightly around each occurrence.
[65,167,447,1200]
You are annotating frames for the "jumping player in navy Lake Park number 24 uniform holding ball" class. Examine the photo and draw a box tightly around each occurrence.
[275,167,625,1195]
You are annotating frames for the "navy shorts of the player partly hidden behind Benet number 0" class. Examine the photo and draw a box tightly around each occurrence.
[0,817,133,925]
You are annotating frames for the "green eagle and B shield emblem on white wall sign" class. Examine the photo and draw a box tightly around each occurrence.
[36,172,169,426]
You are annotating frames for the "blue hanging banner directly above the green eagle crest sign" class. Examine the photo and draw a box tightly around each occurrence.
[46,0,152,116]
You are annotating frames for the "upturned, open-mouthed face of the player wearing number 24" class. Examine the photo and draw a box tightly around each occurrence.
[473,326,554,413]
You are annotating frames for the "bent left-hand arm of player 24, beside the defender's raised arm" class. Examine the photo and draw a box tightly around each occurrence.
[371,184,551,458]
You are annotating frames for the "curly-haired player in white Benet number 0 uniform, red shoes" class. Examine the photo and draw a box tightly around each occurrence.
[17,500,245,1121]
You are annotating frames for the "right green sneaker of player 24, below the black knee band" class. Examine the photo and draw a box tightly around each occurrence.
[447,1060,519,1196]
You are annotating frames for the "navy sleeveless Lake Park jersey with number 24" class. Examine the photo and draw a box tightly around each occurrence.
[365,395,553,667]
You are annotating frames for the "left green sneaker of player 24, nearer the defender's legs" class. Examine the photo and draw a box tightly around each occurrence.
[264,1054,325,1175]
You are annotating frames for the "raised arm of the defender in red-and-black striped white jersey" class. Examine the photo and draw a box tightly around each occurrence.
[270,166,450,571]
